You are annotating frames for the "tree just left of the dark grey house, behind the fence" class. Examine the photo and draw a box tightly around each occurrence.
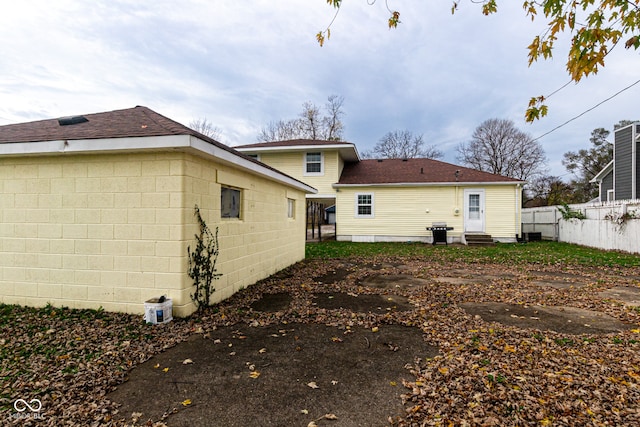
[562,120,634,203]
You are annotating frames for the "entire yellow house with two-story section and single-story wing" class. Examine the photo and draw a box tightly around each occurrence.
[236,140,524,242]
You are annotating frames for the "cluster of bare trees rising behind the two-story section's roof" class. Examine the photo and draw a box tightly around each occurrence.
[257,95,344,142]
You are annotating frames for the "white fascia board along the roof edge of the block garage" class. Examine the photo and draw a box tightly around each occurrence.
[0,135,318,194]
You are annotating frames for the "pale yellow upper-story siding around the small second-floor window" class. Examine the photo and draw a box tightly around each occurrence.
[251,147,344,197]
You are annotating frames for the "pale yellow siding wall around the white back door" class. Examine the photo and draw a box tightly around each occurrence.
[336,185,520,242]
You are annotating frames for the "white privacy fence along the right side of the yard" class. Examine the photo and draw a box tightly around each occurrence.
[522,200,640,253]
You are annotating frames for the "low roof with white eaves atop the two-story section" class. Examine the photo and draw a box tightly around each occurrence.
[233,139,360,162]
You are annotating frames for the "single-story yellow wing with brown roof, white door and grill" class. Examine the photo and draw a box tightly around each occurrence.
[334,159,524,242]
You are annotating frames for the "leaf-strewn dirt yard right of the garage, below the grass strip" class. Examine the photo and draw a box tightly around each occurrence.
[107,259,640,427]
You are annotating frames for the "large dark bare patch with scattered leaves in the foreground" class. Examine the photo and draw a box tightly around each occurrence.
[109,324,437,427]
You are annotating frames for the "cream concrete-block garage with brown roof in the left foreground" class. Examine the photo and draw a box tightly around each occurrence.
[0,107,316,316]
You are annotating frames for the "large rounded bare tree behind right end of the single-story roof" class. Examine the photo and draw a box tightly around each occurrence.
[456,119,547,181]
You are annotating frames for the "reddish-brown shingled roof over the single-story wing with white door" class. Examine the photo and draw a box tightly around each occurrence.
[334,159,525,187]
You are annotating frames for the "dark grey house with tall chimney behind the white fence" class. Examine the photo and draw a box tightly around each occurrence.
[591,122,640,202]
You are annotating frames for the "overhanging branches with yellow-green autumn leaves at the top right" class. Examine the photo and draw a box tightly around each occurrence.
[316,0,640,122]
